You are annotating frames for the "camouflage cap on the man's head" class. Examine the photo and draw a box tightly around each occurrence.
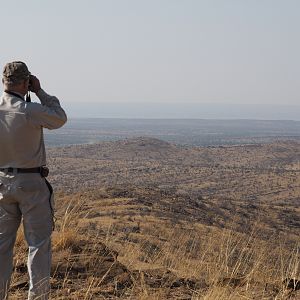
[3,61,30,84]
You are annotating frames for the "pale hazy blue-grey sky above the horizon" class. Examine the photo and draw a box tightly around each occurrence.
[0,0,300,118]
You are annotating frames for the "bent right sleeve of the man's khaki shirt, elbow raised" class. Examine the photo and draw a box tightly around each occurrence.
[26,89,67,129]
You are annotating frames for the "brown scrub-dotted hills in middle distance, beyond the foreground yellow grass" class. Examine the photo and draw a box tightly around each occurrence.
[49,137,300,237]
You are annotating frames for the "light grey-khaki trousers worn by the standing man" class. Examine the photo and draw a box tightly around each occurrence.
[0,172,53,300]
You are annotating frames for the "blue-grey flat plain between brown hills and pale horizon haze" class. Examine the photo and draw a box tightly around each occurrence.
[45,118,300,146]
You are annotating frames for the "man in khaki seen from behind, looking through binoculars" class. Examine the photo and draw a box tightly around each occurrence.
[0,61,67,300]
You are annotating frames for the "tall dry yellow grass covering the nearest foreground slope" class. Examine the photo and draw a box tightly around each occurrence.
[8,191,300,300]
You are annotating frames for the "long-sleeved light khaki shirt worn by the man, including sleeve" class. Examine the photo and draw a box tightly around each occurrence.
[0,90,67,168]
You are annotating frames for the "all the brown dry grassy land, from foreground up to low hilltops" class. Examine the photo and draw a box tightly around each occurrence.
[8,138,300,300]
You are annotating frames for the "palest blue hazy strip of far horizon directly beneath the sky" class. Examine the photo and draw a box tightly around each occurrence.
[62,102,300,121]
